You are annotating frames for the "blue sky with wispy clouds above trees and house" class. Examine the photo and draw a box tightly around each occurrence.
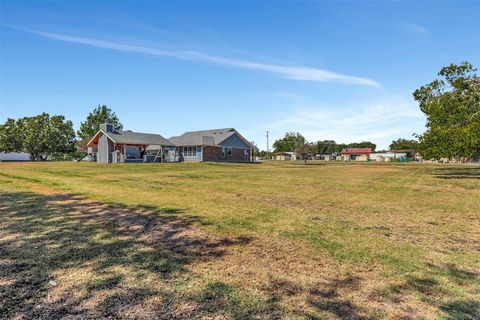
[0,1,480,149]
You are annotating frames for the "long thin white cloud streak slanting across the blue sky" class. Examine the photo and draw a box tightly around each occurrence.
[17,28,381,88]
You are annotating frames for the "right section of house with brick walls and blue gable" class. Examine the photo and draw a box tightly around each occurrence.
[169,128,254,162]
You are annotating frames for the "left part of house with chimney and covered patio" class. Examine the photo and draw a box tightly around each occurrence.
[87,123,174,163]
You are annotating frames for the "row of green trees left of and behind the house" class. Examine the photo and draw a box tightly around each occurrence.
[0,105,122,161]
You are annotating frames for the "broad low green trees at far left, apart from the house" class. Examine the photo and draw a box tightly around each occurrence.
[0,112,75,160]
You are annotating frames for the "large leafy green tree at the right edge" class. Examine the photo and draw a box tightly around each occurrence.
[413,62,480,159]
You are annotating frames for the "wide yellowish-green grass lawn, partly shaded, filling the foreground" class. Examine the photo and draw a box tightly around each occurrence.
[0,162,480,319]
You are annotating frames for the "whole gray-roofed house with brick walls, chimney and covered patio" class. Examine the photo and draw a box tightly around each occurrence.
[87,123,254,163]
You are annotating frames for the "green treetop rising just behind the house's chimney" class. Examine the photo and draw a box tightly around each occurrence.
[77,105,123,141]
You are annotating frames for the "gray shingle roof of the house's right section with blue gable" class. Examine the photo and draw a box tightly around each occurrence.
[170,128,250,146]
